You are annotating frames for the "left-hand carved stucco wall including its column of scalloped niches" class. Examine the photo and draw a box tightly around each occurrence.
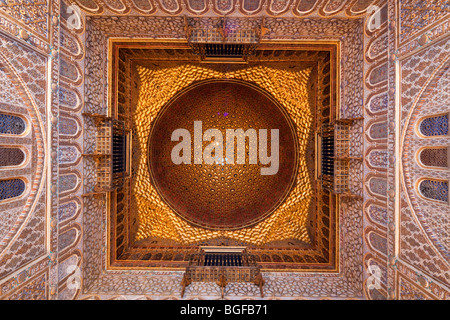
[0,1,84,299]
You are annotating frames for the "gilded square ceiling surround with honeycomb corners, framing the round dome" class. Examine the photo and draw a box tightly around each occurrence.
[110,40,337,270]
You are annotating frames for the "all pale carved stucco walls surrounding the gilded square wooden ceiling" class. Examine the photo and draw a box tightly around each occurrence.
[0,0,449,299]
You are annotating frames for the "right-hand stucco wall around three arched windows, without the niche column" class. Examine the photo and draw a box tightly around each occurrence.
[388,1,450,300]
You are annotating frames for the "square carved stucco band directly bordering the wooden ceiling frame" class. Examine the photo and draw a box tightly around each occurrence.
[81,17,363,299]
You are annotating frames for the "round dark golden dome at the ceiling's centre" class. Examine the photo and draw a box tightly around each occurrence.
[148,79,298,230]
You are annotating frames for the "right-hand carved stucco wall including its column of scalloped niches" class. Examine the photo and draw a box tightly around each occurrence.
[364,1,450,299]
